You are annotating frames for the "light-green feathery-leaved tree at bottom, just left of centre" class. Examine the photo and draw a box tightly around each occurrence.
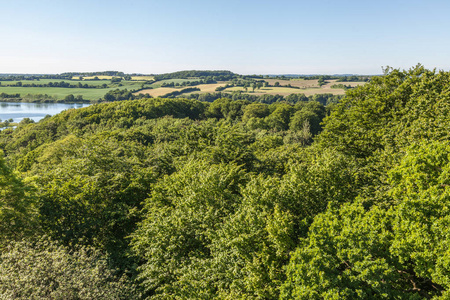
[133,161,245,298]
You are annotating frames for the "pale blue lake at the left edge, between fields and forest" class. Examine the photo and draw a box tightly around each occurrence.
[0,102,90,122]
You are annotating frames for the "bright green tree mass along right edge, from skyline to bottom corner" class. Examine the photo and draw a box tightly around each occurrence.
[282,66,450,299]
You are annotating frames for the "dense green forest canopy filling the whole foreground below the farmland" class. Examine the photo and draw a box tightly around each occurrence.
[0,66,450,299]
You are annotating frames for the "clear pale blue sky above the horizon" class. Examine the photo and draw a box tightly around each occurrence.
[0,0,450,74]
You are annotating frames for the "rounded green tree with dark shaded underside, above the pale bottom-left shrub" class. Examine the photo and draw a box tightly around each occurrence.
[31,136,154,268]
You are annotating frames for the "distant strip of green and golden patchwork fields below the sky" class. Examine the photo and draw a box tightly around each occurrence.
[0,71,365,102]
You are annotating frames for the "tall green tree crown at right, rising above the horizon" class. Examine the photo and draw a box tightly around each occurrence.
[320,65,450,158]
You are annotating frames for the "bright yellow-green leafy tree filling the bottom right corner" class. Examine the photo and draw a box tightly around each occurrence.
[282,141,450,299]
